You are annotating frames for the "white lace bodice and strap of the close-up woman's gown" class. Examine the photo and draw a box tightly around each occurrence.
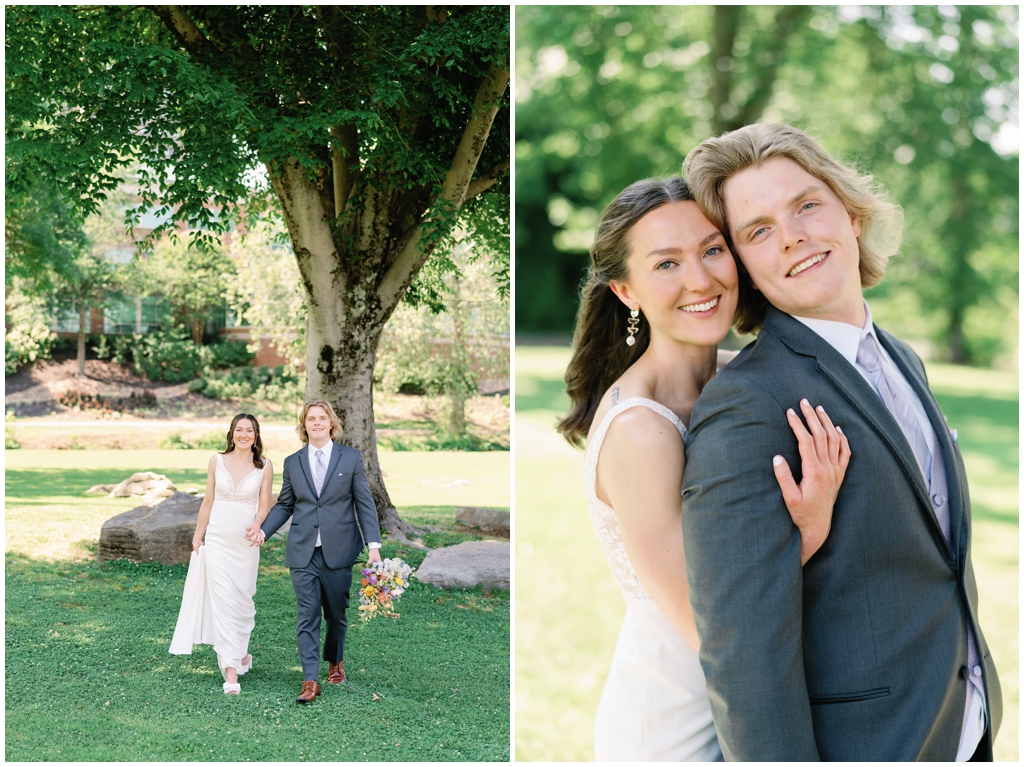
[584,397,686,599]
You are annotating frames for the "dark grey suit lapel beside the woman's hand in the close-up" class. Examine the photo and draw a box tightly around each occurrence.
[764,306,942,537]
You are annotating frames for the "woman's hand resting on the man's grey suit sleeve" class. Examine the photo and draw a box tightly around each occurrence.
[772,399,850,564]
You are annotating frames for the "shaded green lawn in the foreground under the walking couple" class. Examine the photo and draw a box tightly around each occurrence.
[5,539,510,761]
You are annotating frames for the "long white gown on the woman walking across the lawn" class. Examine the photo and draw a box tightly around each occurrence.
[170,454,263,675]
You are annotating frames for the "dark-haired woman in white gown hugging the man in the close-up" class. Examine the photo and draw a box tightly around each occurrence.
[559,178,850,761]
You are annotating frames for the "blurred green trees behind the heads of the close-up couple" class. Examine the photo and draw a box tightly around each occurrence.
[515,5,1019,368]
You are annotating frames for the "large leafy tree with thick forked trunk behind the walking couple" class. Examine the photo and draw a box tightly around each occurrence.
[6,5,509,536]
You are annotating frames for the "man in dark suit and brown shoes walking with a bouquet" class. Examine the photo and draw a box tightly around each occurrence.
[253,399,381,704]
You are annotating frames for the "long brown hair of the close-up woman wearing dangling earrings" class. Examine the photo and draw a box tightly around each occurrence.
[558,176,693,448]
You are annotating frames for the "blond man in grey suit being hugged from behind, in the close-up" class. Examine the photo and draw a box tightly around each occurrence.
[683,125,1001,761]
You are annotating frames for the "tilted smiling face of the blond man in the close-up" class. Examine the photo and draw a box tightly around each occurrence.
[723,157,864,327]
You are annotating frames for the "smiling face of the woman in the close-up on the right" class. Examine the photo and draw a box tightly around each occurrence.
[612,201,739,346]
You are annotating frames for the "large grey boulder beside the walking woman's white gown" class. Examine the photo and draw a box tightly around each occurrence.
[99,493,203,564]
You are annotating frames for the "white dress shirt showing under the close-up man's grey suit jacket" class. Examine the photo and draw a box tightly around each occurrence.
[792,301,985,762]
